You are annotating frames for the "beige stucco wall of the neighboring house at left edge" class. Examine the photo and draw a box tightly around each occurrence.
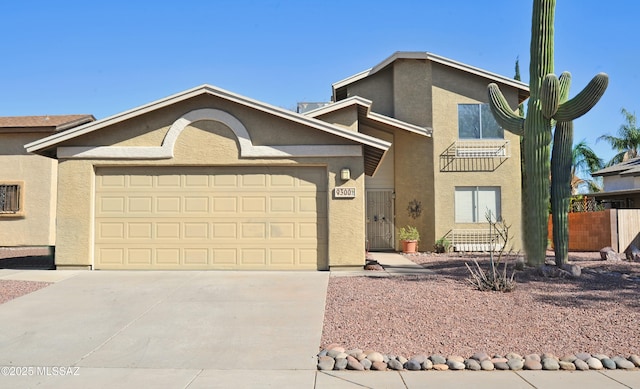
[0,133,57,247]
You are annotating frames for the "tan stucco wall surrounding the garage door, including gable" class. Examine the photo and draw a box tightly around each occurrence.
[56,98,365,269]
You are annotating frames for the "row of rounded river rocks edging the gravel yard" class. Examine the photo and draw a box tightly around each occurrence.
[318,344,640,371]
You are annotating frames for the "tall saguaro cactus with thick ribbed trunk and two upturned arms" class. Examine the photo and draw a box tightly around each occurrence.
[489,0,608,266]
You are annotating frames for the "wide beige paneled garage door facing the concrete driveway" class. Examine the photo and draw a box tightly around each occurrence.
[94,167,327,270]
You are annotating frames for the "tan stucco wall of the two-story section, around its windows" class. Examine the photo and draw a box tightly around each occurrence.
[348,59,522,250]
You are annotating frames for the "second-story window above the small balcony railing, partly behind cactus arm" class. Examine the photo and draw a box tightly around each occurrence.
[458,104,504,139]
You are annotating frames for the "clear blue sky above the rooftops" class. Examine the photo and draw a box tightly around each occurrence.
[0,0,640,164]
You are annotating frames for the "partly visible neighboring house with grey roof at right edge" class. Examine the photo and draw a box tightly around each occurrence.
[589,158,640,208]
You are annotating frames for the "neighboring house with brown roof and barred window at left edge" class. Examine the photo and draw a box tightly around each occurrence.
[0,115,95,247]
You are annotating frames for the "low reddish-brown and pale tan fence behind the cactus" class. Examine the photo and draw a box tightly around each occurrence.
[548,209,640,253]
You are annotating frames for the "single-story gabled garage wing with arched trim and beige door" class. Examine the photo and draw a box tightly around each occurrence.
[26,85,400,269]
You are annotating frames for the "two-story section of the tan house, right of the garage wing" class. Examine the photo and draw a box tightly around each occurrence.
[316,52,529,251]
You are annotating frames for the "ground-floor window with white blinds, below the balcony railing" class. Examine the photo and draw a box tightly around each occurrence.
[454,186,501,223]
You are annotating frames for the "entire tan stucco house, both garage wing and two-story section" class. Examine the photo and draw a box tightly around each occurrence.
[25,53,528,270]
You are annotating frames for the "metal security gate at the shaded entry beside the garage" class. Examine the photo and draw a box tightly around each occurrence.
[367,190,395,250]
